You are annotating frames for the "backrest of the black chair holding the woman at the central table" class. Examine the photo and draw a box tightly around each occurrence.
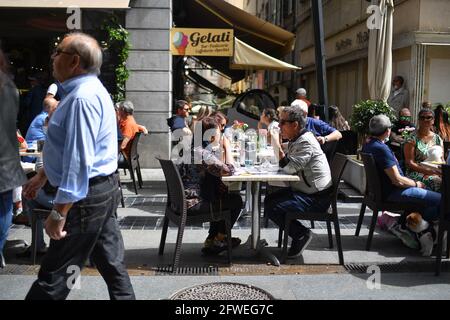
[158,159,187,215]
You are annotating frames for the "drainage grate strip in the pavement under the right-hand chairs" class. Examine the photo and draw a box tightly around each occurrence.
[344,261,450,273]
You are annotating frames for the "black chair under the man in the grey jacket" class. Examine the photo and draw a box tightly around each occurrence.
[278,153,348,265]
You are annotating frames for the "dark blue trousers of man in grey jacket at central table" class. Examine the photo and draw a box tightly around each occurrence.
[264,188,331,239]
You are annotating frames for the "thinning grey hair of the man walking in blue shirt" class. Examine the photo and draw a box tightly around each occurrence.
[65,32,103,76]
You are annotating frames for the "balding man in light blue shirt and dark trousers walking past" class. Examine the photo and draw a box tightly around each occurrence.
[24,33,135,300]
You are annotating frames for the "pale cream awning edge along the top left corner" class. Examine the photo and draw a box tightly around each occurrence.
[0,0,130,9]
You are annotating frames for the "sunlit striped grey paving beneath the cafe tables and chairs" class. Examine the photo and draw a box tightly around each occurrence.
[7,152,450,274]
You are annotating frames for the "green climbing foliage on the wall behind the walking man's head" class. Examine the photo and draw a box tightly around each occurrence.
[102,15,131,102]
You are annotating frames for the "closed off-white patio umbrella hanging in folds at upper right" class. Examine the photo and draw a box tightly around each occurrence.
[368,0,394,101]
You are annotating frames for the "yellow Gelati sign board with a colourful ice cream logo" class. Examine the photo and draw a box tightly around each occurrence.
[170,28,234,57]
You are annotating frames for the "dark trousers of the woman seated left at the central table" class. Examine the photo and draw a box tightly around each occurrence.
[188,193,242,239]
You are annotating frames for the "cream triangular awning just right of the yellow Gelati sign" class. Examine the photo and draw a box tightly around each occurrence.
[234,38,301,71]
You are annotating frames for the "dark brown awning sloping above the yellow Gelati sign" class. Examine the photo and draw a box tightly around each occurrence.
[174,0,295,58]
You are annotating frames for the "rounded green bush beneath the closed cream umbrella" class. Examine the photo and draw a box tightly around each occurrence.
[350,100,397,136]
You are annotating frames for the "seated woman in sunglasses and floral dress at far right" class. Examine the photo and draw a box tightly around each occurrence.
[404,109,444,191]
